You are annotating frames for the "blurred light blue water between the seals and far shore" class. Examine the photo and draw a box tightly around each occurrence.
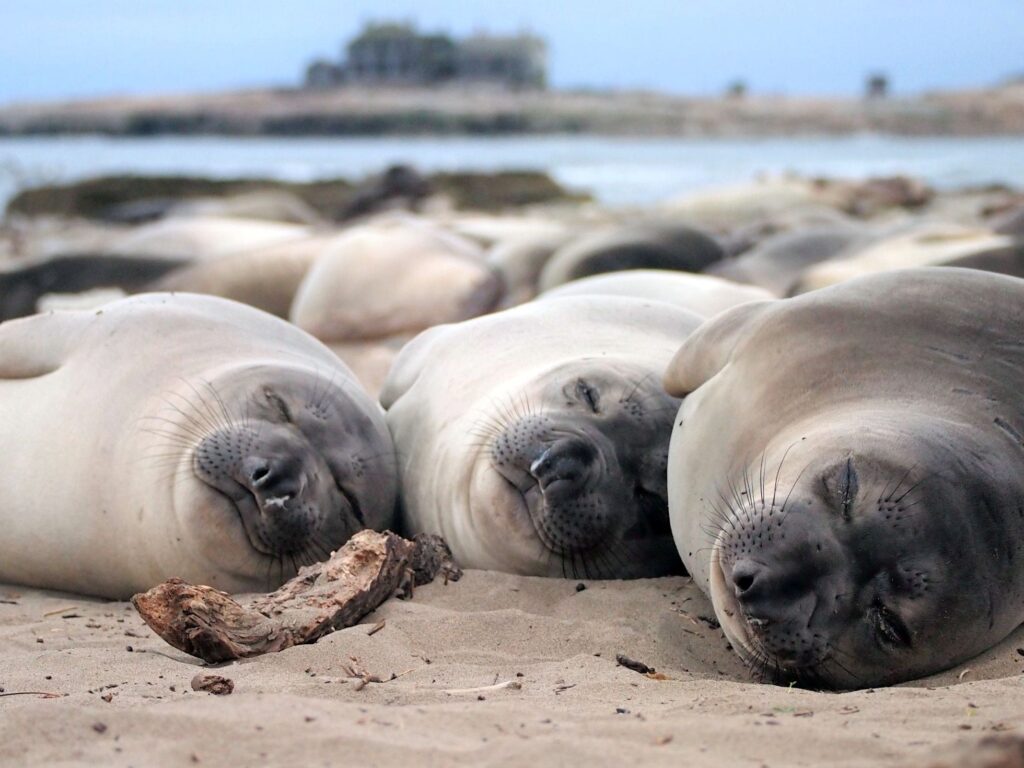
[0,135,1024,208]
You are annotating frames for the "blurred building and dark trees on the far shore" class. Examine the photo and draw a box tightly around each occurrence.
[305,23,547,88]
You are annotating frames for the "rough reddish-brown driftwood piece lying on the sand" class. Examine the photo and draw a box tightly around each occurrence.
[131,530,462,663]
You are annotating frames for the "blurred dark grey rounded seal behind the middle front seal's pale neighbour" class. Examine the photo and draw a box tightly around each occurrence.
[539,222,725,292]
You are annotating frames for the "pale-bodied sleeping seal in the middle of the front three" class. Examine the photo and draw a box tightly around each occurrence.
[381,296,700,579]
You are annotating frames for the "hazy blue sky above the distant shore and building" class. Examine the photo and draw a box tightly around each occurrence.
[0,0,1024,103]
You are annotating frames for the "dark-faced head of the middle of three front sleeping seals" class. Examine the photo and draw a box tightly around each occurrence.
[466,358,682,578]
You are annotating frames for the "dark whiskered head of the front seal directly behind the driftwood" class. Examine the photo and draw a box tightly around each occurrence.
[156,365,396,582]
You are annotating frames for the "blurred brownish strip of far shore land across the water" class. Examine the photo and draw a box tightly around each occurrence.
[0,84,1024,138]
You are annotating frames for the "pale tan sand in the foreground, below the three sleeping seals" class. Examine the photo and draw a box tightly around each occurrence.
[0,571,1024,767]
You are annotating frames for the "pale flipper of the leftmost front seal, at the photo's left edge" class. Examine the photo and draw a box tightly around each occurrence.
[0,311,83,380]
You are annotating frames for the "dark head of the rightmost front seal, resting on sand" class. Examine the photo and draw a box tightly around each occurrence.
[706,415,1018,688]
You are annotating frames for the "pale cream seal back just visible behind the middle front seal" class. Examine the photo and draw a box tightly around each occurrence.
[540,269,774,317]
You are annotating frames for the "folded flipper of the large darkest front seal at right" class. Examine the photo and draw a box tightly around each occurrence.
[663,300,778,397]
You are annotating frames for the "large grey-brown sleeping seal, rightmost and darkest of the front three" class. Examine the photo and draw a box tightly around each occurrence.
[665,267,1024,688]
